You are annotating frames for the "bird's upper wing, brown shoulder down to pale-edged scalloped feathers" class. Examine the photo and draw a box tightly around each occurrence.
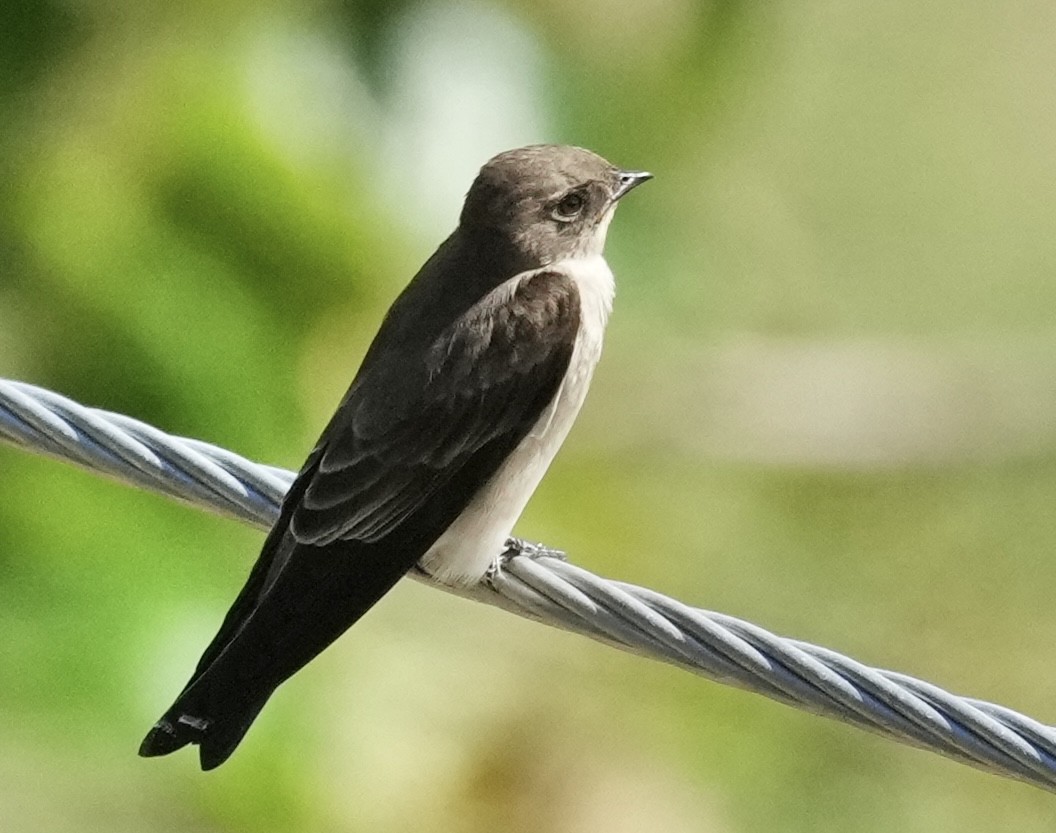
[290,269,580,546]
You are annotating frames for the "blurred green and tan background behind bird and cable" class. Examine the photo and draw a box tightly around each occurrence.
[0,0,1056,833]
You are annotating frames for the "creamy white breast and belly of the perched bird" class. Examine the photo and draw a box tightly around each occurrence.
[421,254,616,584]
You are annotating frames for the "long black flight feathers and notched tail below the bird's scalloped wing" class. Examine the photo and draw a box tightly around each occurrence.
[139,428,528,770]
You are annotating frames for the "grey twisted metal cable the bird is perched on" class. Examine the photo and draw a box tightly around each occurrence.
[0,379,1056,792]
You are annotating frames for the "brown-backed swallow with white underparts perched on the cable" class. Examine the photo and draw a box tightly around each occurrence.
[139,145,652,771]
